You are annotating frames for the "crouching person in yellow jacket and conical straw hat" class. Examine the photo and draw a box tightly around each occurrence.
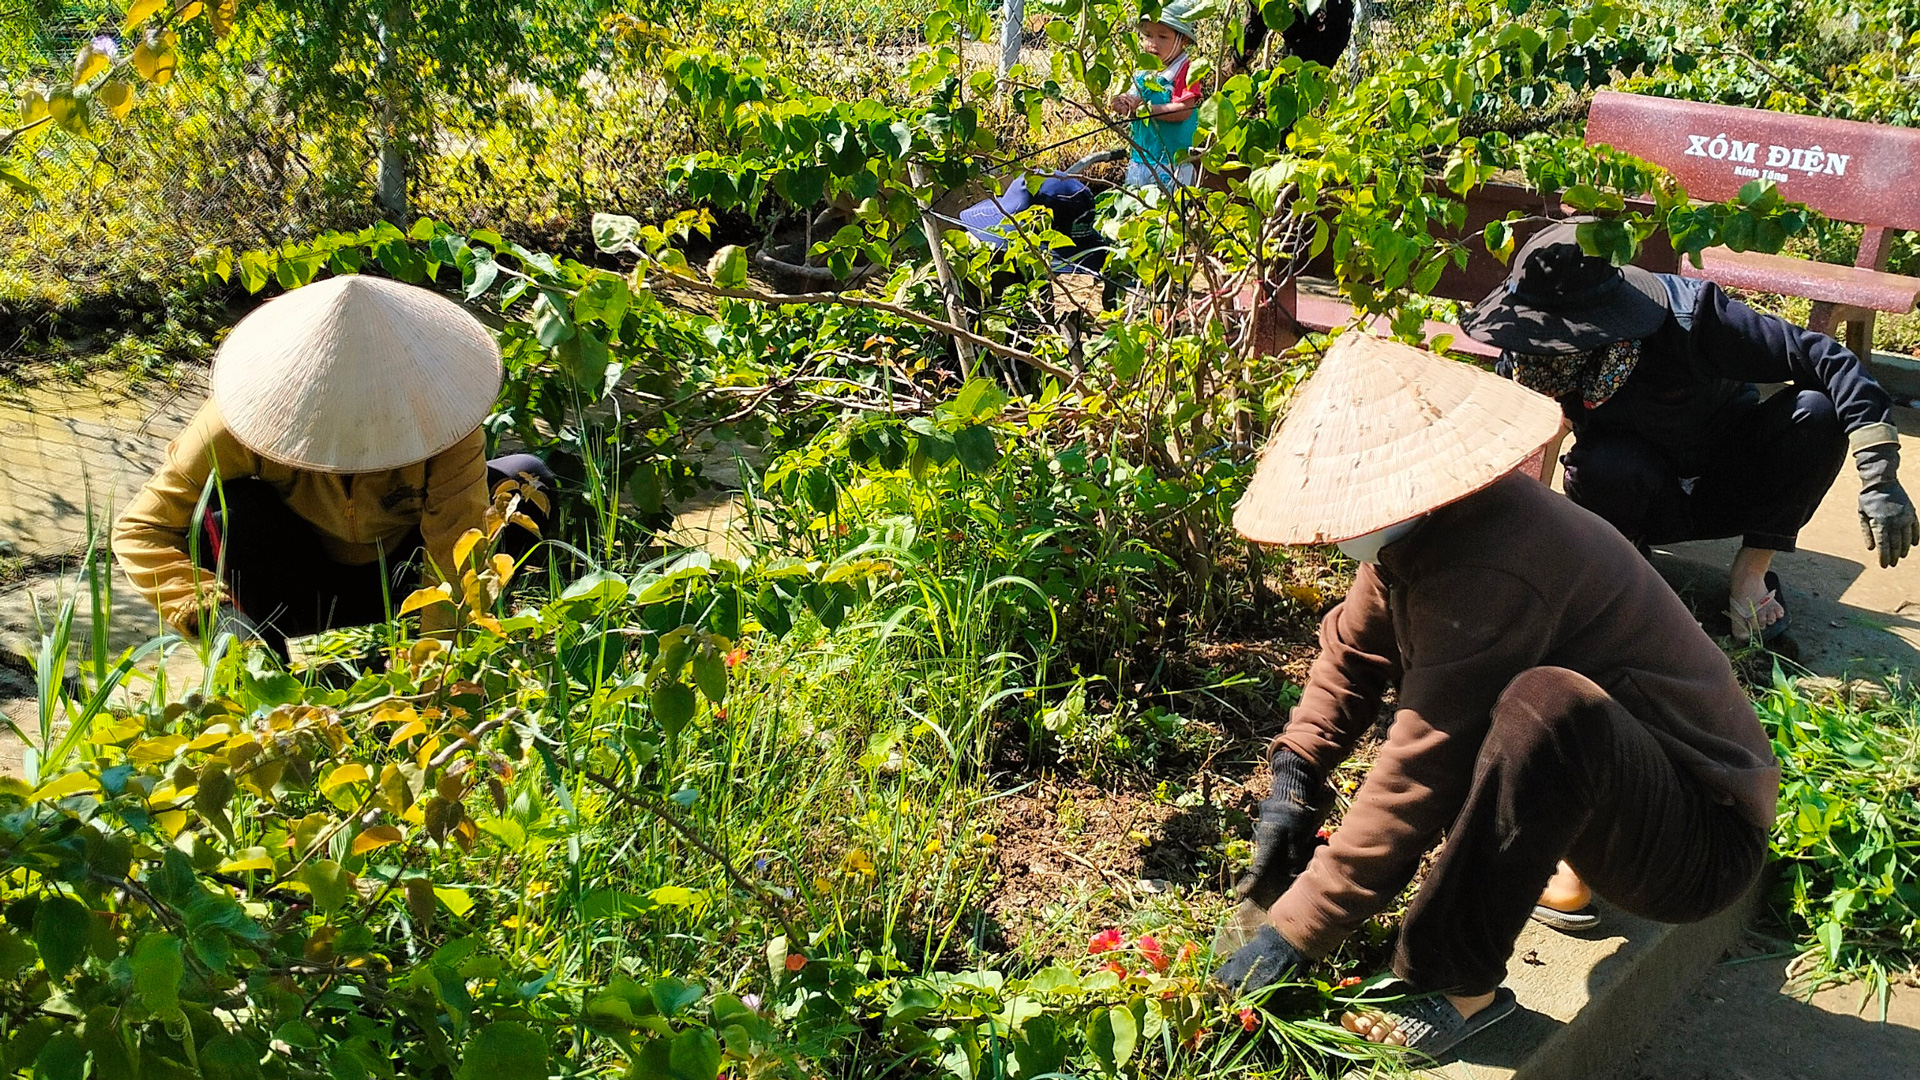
[113,275,553,657]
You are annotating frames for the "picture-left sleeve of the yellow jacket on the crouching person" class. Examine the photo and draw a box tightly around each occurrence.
[113,402,259,634]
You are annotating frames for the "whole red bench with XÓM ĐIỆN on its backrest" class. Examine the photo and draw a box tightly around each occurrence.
[1586,90,1920,361]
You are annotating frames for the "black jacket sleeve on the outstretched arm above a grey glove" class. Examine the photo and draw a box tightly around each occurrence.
[1668,281,1893,434]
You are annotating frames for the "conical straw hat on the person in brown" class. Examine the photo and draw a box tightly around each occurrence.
[1233,331,1561,544]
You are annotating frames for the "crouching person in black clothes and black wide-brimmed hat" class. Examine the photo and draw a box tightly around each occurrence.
[1463,217,1920,642]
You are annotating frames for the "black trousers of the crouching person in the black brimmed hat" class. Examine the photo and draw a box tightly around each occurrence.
[1561,388,1847,552]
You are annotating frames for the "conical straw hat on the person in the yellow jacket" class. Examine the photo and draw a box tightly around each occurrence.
[213,275,501,473]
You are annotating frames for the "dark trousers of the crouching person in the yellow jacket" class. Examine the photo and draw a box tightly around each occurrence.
[196,454,555,657]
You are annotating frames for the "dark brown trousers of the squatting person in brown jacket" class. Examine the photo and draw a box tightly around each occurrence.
[1394,667,1766,994]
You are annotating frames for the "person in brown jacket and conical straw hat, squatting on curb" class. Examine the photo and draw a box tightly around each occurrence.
[1215,332,1780,1053]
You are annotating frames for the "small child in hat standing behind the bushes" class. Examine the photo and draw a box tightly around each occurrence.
[1110,0,1206,190]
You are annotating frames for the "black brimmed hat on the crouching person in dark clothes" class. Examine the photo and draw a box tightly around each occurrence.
[1463,217,1667,356]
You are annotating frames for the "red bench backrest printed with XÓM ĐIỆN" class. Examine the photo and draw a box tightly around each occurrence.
[1586,90,1920,229]
